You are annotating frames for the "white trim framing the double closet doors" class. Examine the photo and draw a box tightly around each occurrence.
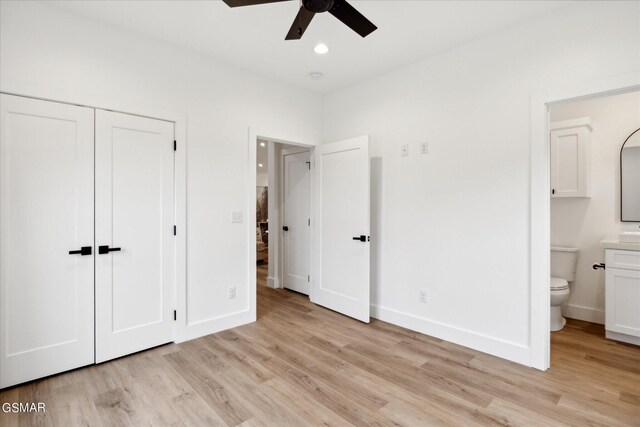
[0,84,189,343]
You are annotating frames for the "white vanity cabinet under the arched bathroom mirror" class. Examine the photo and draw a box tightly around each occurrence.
[605,249,640,345]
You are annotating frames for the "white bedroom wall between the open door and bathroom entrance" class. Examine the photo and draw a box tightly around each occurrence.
[324,2,640,364]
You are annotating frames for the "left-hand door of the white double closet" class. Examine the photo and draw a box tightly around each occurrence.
[0,95,94,387]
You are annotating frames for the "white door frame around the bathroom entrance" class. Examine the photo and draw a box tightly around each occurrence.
[518,72,640,371]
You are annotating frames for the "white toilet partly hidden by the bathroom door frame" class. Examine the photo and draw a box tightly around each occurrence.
[550,246,578,332]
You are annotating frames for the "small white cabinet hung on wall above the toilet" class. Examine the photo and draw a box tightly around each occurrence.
[550,118,591,198]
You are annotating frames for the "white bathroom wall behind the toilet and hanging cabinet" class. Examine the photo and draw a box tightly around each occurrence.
[550,92,640,324]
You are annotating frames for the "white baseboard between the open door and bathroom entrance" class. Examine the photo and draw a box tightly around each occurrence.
[371,305,533,366]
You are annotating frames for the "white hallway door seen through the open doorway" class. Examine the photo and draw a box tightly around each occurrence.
[283,151,311,295]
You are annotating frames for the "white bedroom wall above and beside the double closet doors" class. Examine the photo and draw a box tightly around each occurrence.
[0,1,322,337]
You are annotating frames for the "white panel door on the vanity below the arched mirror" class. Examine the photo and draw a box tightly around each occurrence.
[605,265,640,337]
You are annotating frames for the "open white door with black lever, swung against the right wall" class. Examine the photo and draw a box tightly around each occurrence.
[311,136,370,322]
